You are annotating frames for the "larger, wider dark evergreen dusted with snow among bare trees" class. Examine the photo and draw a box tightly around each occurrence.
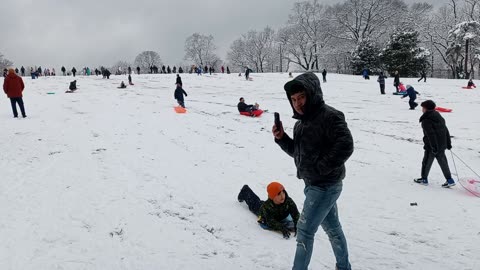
[381,31,430,77]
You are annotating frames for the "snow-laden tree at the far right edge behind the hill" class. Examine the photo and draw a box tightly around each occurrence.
[446,21,480,78]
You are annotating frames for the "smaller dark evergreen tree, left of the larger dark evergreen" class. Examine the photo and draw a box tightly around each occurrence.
[350,40,380,74]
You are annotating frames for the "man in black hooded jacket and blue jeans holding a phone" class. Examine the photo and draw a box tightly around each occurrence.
[272,72,353,270]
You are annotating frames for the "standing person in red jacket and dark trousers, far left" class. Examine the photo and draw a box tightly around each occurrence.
[3,68,27,118]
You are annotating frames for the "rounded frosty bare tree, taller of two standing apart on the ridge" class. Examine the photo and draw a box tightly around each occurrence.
[185,33,220,66]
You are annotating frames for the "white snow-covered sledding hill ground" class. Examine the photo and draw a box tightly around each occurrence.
[0,74,480,270]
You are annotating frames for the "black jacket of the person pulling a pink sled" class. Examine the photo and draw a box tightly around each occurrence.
[420,110,452,153]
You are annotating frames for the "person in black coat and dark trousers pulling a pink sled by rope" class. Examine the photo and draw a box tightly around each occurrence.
[414,100,455,188]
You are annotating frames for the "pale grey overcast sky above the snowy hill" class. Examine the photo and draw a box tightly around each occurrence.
[0,0,447,69]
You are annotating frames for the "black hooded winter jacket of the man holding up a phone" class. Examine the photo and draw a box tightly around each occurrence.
[275,72,353,186]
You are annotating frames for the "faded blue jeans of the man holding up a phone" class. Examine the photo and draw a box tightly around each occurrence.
[293,182,351,270]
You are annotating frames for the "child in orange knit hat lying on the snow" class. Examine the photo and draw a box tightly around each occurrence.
[238,182,300,239]
